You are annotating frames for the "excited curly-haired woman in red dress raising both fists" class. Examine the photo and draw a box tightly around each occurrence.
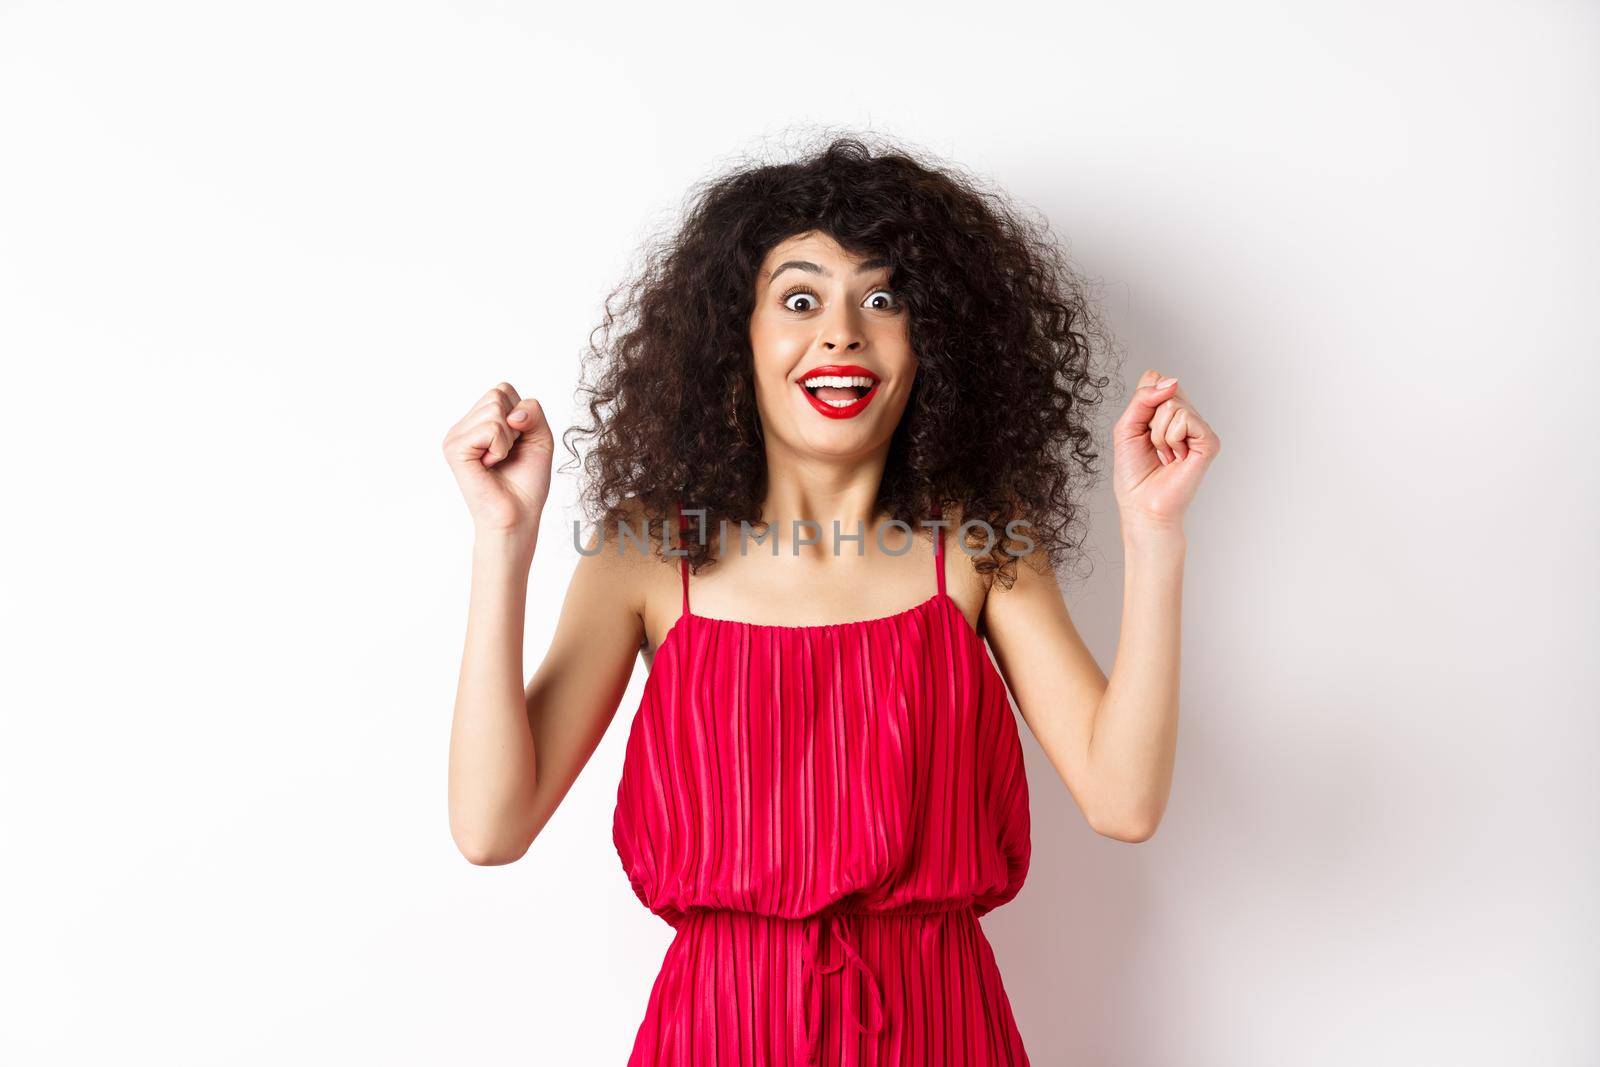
[445,139,1219,1067]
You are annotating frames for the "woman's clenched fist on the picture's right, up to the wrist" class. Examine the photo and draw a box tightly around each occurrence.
[1112,370,1222,534]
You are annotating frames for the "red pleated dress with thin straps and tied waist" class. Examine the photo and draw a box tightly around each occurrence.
[613,512,1030,1067]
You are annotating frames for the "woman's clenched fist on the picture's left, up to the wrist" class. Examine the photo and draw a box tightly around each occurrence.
[443,382,555,534]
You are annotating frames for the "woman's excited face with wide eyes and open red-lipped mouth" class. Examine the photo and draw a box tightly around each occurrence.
[750,232,917,459]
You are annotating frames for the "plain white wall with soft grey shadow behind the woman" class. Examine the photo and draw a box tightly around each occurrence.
[0,2,1600,1067]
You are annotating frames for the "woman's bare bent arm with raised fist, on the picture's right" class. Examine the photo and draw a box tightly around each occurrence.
[984,371,1221,841]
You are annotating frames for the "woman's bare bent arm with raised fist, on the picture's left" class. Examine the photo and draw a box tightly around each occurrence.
[445,382,643,864]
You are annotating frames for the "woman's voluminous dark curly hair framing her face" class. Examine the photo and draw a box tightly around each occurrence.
[562,134,1110,585]
